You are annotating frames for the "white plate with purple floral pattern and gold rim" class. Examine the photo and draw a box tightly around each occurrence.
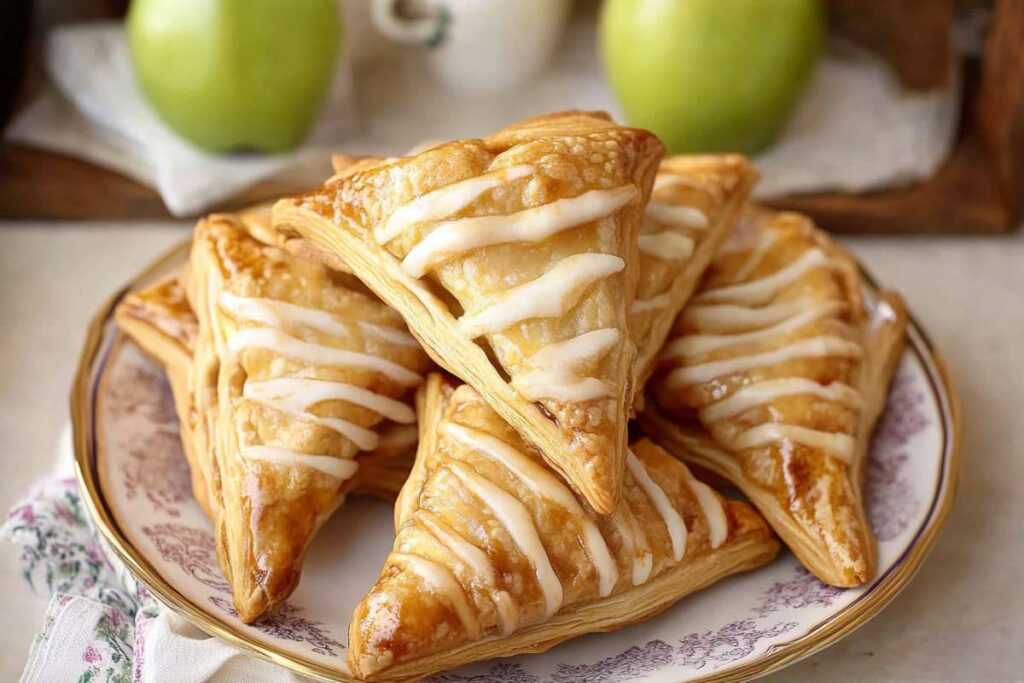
[72,239,959,683]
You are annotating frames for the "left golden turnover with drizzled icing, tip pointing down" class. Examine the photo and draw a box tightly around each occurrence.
[187,215,429,623]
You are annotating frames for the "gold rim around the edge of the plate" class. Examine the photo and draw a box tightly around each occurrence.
[71,239,962,683]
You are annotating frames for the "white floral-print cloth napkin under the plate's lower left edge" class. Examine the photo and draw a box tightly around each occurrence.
[0,429,308,683]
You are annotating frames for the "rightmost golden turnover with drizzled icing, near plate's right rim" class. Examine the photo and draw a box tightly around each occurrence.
[641,210,906,587]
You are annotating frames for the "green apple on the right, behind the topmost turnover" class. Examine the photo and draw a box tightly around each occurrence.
[600,0,825,154]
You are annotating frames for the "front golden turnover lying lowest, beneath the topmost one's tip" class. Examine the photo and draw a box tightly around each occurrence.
[348,375,779,681]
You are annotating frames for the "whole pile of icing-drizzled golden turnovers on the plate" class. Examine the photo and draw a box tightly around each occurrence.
[110,112,905,680]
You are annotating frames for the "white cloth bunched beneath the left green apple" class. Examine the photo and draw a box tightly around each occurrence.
[7,22,354,216]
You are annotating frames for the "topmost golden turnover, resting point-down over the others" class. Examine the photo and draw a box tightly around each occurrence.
[273,112,663,512]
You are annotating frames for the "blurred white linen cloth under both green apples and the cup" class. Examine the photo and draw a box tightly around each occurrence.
[7,18,959,216]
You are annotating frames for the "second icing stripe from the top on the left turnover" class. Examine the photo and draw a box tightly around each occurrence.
[227,328,423,386]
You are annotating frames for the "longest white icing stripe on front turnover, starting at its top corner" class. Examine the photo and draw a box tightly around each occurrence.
[440,422,618,598]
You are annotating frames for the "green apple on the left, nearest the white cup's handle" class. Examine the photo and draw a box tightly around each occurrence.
[127,0,341,152]
